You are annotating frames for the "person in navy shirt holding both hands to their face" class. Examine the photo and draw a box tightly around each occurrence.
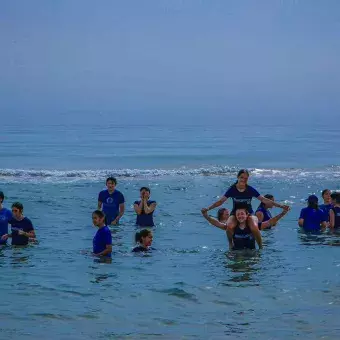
[133,187,157,227]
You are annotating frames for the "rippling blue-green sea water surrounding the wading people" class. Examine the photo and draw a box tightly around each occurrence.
[0,121,340,339]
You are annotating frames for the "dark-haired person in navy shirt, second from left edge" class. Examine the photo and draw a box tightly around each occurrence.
[1,202,35,246]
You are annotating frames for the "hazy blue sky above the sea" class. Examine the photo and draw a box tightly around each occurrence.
[0,0,340,122]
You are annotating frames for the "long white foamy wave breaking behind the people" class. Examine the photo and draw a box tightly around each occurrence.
[0,166,340,182]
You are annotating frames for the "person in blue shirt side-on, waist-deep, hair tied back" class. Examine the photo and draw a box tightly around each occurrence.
[92,210,112,257]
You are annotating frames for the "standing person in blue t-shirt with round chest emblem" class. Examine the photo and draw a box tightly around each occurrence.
[98,177,125,225]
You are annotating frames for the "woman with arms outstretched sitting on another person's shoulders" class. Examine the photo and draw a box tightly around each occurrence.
[203,169,289,248]
